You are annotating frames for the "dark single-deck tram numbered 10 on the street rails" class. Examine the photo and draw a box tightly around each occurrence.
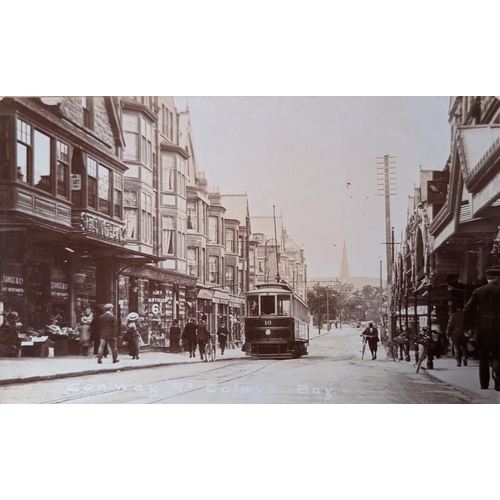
[243,282,309,358]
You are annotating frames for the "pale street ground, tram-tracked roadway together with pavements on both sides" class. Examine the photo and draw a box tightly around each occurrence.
[0,326,488,404]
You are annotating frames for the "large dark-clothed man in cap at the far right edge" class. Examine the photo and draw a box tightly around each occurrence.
[463,266,500,391]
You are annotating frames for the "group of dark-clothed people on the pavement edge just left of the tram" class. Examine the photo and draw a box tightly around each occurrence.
[174,315,229,359]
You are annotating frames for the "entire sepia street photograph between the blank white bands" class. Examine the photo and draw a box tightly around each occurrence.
[0,96,500,404]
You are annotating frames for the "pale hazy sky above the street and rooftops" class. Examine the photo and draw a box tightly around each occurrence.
[175,96,450,279]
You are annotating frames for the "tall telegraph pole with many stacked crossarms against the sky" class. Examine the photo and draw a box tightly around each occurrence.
[377,155,396,339]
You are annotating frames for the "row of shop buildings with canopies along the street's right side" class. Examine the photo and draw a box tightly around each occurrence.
[392,96,500,348]
